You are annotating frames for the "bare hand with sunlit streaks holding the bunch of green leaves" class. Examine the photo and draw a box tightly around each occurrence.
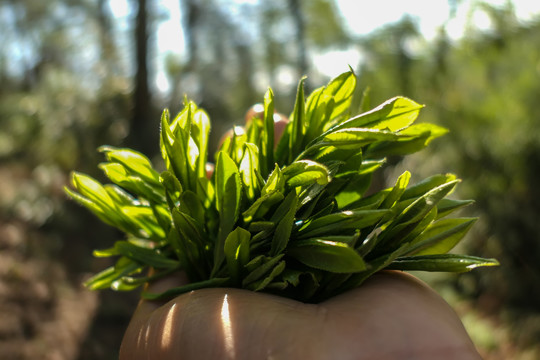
[120,271,480,360]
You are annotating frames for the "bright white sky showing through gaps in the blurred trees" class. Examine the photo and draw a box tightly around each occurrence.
[111,0,540,91]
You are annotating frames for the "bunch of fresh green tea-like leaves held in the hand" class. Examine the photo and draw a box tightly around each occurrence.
[66,71,497,302]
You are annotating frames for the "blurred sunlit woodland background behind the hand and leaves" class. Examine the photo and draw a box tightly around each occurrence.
[0,0,540,360]
